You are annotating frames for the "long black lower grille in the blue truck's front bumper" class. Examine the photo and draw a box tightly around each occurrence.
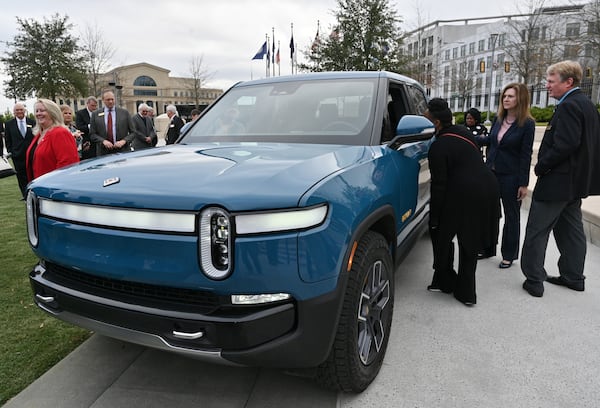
[44,262,219,314]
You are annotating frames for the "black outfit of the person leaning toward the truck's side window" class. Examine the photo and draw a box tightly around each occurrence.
[429,126,500,303]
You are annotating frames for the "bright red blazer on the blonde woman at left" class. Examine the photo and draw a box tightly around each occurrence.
[26,126,79,181]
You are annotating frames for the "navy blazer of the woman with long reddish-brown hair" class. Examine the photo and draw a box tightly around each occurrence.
[479,118,535,186]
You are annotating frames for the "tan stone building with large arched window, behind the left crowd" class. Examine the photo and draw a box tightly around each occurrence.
[59,62,223,117]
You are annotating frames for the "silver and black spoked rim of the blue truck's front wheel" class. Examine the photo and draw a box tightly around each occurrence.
[358,260,390,365]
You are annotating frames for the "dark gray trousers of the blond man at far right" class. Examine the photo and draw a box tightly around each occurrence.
[521,199,587,283]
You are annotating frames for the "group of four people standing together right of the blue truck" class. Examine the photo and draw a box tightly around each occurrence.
[425,61,600,306]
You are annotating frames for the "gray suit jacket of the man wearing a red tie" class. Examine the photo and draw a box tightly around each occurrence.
[90,107,135,156]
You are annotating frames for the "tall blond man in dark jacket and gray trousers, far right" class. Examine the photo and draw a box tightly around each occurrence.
[521,61,600,297]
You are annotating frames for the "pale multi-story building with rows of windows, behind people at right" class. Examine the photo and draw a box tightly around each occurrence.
[404,5,600,117]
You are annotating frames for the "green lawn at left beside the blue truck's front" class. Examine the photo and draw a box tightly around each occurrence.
[0,176,90,406]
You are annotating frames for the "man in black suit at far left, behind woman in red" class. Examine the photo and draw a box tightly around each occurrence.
[4,102,35,198]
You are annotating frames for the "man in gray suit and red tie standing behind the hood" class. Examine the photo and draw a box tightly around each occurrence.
[90,91,135,156]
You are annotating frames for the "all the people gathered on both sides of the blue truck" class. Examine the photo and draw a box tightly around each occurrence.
[0,61,600,306]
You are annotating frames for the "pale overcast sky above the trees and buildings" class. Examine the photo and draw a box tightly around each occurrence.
[0,0,515,112]
